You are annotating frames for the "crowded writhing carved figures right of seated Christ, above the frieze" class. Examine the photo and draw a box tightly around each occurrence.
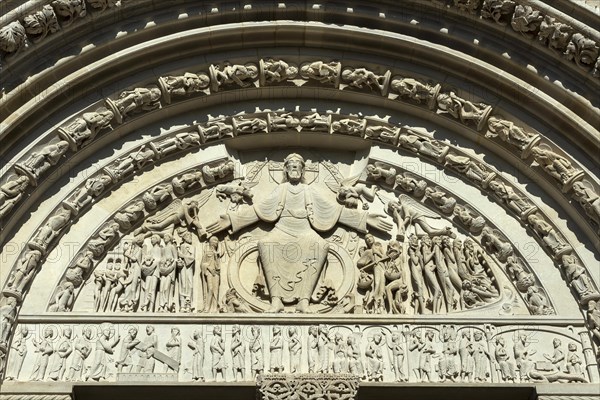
[358,234,500,314]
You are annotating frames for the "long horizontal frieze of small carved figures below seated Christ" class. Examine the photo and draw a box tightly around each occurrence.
[6,323,589,383]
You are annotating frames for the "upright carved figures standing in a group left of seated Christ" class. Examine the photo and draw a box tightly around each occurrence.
[93,231,224,313]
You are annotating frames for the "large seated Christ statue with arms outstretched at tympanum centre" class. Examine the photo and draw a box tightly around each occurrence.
[207,153,392,312]
